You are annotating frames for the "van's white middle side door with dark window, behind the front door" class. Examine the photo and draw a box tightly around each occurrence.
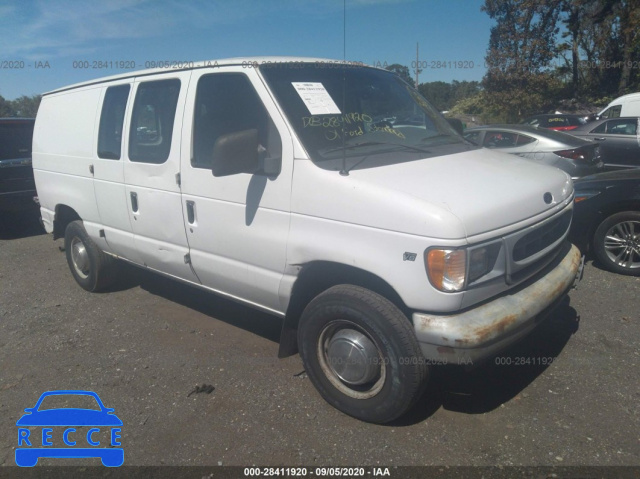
[123,71,200,284]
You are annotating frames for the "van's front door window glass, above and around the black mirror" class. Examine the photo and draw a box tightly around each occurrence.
[191,73,282,169]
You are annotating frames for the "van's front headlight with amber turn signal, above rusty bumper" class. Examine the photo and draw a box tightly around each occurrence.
[424,242,501,293]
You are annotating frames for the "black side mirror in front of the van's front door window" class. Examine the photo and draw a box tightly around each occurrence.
[211,129,260,176]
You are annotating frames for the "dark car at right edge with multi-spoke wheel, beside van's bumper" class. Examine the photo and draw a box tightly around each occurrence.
[570,169,640,276]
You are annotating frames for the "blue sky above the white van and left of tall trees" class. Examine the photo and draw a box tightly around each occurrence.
[0,0,492,100]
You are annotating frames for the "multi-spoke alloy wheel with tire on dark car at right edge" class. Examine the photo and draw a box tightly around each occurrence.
[593,211,640,276]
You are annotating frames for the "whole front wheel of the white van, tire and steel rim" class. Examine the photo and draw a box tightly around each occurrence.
[298,285,428,424]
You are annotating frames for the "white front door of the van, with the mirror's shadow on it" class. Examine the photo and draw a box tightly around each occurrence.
[181,67,293,315]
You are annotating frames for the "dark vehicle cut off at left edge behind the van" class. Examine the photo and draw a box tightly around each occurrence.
[0,118,36,213]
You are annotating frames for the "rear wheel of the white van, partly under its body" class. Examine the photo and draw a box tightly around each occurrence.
[64,221,117,292]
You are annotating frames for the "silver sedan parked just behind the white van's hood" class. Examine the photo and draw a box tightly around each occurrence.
[464,125,603,178]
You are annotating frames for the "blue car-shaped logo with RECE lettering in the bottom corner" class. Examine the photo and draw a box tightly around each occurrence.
[16,390,124,467]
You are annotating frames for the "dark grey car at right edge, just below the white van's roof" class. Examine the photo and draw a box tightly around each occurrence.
[571,116,640,170]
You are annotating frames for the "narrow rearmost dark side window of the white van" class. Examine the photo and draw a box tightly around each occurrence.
[98,85,131,160]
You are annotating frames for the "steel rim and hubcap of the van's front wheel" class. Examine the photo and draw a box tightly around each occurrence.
[317,319,387,399]
